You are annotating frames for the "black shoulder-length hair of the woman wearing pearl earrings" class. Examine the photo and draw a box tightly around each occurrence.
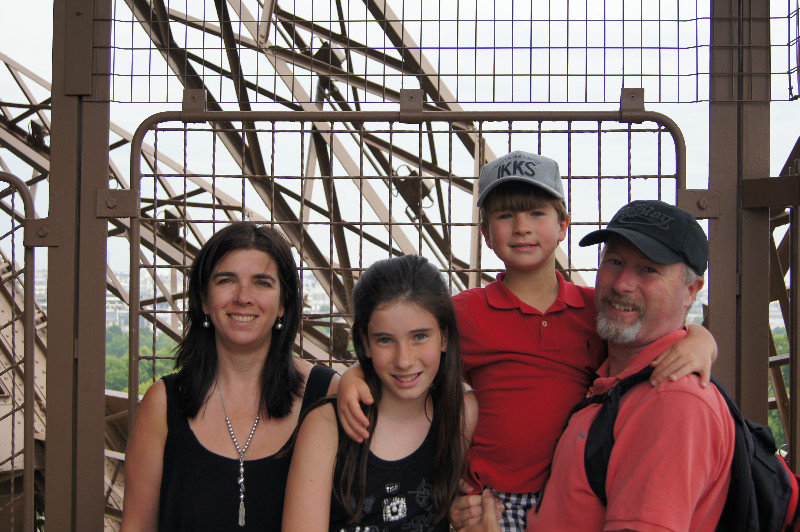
[175,222,303,418]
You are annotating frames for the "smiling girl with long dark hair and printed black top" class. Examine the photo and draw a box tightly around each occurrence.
[283,255,477,532]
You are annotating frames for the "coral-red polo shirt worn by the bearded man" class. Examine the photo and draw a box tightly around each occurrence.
[528,330,734,532]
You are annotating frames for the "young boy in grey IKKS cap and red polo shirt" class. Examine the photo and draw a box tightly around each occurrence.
[339,151,716,531]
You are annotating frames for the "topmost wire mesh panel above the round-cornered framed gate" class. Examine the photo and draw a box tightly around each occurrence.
[112,0,798,106]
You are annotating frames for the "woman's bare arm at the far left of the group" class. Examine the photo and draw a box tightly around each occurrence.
[121,381,167,532]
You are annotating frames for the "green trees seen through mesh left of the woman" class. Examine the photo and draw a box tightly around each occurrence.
[106,325,177,394]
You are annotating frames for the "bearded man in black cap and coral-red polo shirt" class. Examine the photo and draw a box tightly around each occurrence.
[529,201,735,532]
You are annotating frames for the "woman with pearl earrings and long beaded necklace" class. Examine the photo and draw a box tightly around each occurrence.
[122,222,338,532]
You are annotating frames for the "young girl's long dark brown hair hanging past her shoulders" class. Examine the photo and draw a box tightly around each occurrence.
[335,255,466,521]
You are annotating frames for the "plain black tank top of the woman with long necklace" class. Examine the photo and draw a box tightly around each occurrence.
[158,366,335,532]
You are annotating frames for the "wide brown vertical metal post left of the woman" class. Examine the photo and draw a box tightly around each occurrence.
[45,0,112,530]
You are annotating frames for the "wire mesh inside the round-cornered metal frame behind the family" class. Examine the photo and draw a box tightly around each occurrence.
[123,116,680,404]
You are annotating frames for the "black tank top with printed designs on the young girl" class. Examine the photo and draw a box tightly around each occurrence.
[329,400,450,532]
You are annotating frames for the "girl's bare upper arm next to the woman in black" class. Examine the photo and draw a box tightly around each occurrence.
[281,404,339,532]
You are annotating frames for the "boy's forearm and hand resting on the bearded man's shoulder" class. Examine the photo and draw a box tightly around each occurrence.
[650,323,717,388]
